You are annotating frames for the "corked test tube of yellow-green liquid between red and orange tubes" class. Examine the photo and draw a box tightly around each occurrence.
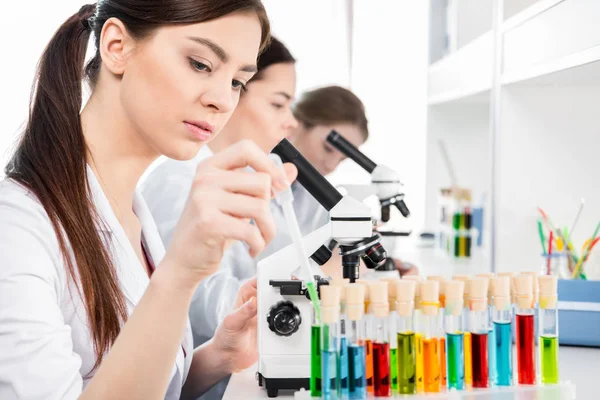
[396,279,417,394]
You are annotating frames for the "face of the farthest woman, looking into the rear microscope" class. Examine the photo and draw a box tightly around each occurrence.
[293,124,365,175]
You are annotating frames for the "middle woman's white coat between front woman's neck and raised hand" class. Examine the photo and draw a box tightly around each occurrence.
[142,160,196,248]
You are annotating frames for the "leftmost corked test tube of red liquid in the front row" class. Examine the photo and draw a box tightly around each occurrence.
[370,282,392,397]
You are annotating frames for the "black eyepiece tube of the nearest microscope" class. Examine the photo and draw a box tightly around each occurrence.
[271,139,343,211]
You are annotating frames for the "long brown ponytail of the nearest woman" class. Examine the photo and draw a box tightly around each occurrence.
[6,5,127,371]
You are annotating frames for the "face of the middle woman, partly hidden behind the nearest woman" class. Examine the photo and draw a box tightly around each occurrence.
[227,63,298,153]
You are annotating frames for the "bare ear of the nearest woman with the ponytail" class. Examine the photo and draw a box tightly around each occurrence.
[99,18,135,75]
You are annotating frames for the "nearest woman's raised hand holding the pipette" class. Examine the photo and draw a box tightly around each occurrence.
[165,140,297,287]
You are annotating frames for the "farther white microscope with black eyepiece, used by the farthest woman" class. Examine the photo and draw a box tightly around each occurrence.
[327,130,411,277]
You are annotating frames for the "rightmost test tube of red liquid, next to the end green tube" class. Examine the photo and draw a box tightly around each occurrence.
[515,275,535,385]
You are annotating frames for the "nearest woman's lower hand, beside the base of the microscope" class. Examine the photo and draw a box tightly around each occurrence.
[212,278,258,373]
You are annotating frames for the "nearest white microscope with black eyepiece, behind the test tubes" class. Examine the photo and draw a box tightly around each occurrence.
[257,139,387,397]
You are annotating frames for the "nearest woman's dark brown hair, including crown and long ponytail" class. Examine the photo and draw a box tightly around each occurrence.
[6,0,270,370]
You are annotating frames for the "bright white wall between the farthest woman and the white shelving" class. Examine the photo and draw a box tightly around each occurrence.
[335,0,429,230]
